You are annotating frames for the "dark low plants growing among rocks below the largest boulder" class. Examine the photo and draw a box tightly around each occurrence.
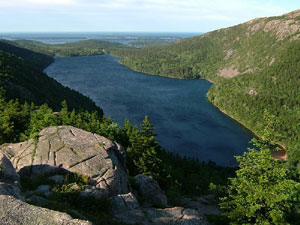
[21,173,115,225]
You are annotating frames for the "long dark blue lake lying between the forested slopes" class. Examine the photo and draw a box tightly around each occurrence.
[45,55,253,165]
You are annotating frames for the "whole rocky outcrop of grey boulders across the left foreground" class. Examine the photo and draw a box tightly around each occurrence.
[0,126,214,225]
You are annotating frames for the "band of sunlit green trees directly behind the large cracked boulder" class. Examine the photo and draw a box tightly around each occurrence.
[0,97,116,144]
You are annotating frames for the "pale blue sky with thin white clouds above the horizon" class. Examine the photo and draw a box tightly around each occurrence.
[0,0,300,32]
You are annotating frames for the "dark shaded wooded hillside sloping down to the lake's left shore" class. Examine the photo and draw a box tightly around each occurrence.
[0,48,103,115]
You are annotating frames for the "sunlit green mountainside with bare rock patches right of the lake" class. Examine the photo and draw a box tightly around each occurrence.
[112,10,300,158]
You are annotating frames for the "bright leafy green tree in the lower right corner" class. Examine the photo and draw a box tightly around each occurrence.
[220,141,300,225]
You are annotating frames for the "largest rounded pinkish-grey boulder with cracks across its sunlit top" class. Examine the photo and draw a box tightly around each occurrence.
[0,126,129,198]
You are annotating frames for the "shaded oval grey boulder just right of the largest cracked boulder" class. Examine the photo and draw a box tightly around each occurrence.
[135,174,168,206]
